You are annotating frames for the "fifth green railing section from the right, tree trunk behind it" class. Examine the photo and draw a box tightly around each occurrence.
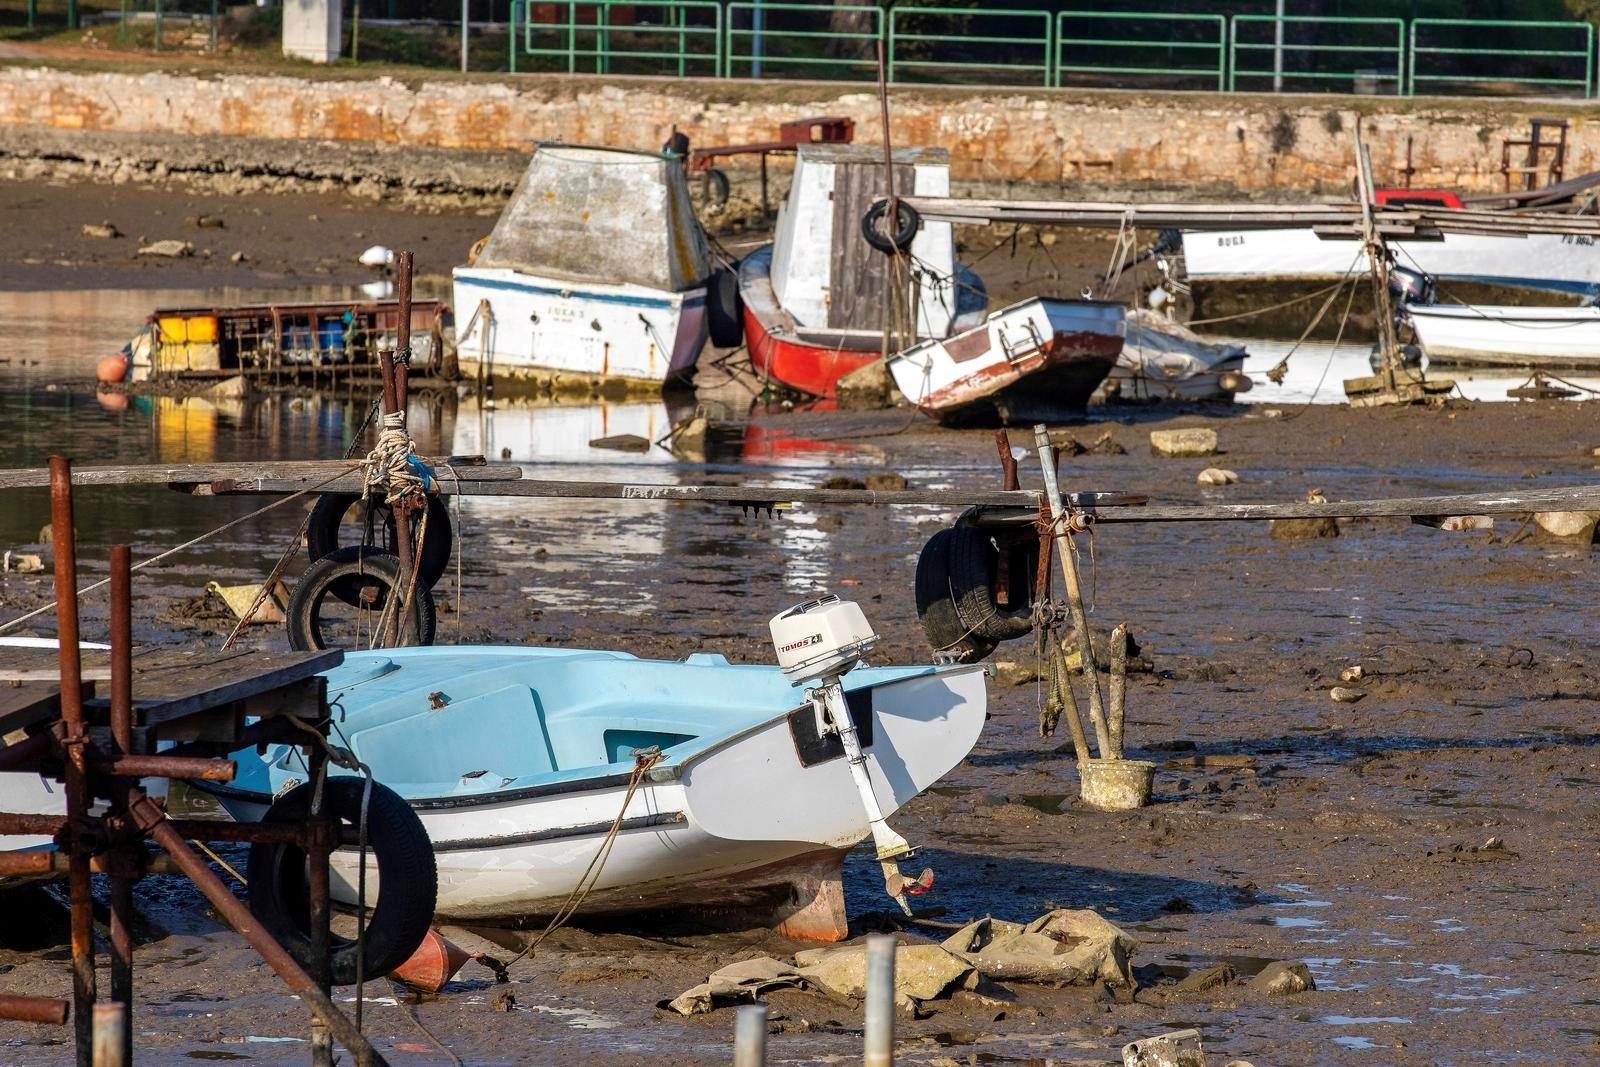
[723,3,883,82]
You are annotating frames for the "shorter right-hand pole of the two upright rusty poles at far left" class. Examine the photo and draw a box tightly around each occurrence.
[108,544,134,1065]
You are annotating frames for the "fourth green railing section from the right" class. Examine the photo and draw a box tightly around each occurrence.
[885,6,1053,85]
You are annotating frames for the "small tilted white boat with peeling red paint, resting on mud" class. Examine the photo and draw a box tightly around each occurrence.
[888,296,1126,422]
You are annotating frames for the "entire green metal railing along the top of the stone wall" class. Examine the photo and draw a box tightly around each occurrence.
[499,0,1600,99]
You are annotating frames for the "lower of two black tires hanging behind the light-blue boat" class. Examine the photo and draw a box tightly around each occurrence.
[288,545,437,653]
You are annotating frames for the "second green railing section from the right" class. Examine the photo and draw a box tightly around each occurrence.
[1227,14,1406,96]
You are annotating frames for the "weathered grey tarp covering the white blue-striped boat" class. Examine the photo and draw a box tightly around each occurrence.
[475,144,710,293]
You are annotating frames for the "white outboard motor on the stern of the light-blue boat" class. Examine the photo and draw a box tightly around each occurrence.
[770,593,933,915]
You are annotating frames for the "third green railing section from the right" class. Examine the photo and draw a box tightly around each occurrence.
[1056,11,1227,90]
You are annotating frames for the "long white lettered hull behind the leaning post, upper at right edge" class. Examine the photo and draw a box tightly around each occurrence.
[1184,229,1600,294]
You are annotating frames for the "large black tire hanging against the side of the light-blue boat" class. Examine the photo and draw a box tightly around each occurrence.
[246,774,438,985]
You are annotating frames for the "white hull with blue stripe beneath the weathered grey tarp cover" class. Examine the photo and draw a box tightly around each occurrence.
[454,267,707,387]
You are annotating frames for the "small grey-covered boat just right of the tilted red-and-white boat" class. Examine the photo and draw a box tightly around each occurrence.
[1102,307,1251,400]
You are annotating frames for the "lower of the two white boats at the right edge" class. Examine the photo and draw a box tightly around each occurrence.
[1405,304,1600,370]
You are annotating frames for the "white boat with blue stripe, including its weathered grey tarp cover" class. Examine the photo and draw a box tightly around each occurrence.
[454,144,712,387]
